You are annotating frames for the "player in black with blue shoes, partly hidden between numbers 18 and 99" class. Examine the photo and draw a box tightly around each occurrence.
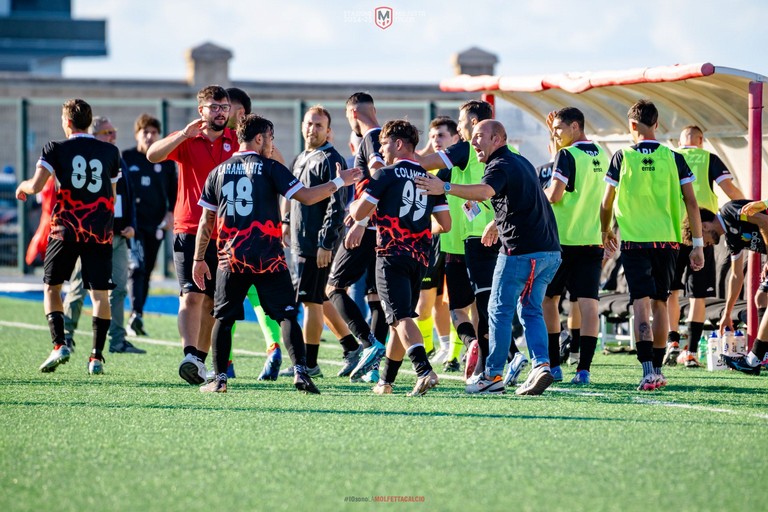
[326,92,388,381]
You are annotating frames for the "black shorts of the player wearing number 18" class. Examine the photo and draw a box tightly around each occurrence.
[218,269,298,323]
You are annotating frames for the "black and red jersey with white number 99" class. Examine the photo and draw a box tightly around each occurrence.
[363,160,448,267]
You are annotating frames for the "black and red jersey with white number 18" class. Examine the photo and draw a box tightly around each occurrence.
[198,151,304,274]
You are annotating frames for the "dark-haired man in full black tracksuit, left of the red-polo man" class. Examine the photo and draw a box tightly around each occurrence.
[123,114,177,336]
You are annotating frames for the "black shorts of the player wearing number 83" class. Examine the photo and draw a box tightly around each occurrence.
[43,238,115,290]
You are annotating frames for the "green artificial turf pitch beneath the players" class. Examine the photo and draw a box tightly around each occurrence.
[0,298,768,512]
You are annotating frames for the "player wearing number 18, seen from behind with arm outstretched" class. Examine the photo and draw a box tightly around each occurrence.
[192,114,361,393]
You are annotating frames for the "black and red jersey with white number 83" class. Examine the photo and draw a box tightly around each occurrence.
[37,133,120,244]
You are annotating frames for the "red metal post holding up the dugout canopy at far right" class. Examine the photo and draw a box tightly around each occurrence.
[746,82,763,349]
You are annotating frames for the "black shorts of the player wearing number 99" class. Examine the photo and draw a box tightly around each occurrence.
[376,256,427,325]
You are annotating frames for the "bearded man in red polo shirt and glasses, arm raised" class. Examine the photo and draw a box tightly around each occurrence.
[147,85,238,384]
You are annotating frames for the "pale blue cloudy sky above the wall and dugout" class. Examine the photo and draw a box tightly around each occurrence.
[64,0,768,83]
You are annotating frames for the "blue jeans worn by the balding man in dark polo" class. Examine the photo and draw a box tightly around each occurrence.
[485,251,560,377]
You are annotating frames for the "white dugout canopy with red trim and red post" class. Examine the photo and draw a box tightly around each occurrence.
[440,63,768,339]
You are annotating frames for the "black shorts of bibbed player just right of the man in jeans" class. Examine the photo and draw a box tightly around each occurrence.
[546,245,603,302]
